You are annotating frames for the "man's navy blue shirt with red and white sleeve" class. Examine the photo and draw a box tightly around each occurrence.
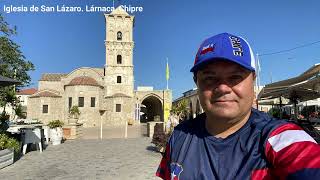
[156,109,320,180]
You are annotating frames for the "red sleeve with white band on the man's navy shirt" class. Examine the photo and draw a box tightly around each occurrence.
[265,123,320,179]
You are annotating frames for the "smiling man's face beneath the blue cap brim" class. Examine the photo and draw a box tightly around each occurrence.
[196,60,255,120]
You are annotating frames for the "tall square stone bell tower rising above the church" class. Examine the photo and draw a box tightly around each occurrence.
[105,6,134,97]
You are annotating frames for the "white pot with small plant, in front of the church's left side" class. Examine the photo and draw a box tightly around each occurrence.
[48,120,64,145]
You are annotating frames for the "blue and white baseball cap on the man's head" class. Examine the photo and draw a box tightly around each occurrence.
[190,33,255,72]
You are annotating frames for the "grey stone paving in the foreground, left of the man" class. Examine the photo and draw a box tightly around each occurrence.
[0,137,161,180]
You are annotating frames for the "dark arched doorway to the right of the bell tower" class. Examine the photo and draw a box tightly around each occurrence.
[140,95,163,123]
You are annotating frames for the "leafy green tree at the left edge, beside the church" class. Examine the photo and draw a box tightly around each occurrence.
[0,13,34,116]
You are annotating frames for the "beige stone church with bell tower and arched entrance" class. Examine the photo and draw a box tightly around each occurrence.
[27,6,172,127]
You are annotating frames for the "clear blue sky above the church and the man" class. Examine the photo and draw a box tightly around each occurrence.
[0,0,320,98]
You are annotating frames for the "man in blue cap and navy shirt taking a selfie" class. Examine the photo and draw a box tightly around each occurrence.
[156,33,320,180]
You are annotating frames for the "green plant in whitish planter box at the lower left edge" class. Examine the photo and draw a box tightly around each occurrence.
[0,133,20,169]
